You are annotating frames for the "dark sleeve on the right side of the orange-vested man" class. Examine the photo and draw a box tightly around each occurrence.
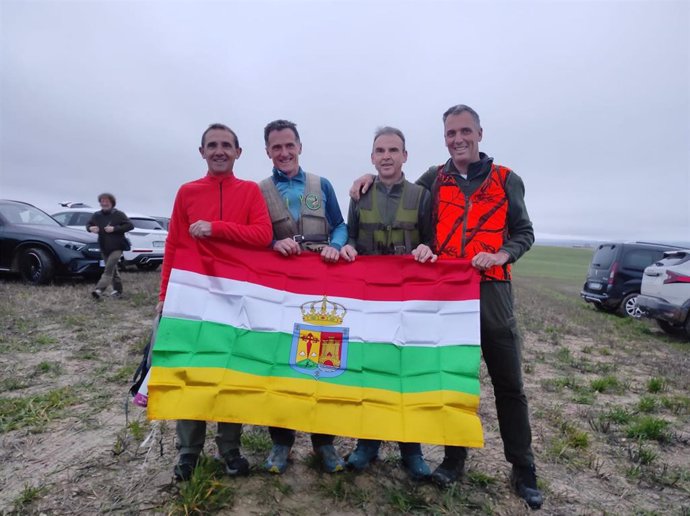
[500,172,534,263]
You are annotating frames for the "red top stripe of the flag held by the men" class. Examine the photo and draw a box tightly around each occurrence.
[166,240,479,301]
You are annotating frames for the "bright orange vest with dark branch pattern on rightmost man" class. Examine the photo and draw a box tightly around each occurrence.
[433,164,511,281]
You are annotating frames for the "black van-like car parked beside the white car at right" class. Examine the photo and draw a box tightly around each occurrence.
[580,242,678,318]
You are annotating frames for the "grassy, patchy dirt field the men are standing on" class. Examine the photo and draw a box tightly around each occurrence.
[0,247,690,516]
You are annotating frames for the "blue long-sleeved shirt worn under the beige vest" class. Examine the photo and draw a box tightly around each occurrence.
[271,167,347,250]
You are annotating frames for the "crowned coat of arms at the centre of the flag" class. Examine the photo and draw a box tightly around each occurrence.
[290,296,349,380]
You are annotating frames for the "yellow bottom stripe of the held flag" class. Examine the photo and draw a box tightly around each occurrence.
[148,367,484,447]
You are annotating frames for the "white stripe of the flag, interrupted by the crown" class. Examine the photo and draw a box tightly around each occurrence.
[163,269,479,346]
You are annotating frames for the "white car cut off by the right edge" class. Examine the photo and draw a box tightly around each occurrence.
[637,249,690,338]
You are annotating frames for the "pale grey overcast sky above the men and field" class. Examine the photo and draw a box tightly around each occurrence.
[0,0,690,240]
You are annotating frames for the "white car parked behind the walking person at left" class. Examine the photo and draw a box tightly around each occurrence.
[53,208,168,270]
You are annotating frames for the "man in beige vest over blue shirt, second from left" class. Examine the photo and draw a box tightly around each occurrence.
[259,120,348,474]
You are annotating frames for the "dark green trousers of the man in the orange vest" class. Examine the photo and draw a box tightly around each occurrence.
[446,281,534,466]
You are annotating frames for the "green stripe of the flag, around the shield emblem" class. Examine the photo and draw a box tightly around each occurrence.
[153,317,481,395]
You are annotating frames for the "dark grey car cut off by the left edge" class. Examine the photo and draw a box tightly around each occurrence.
[0,200,103,284]
